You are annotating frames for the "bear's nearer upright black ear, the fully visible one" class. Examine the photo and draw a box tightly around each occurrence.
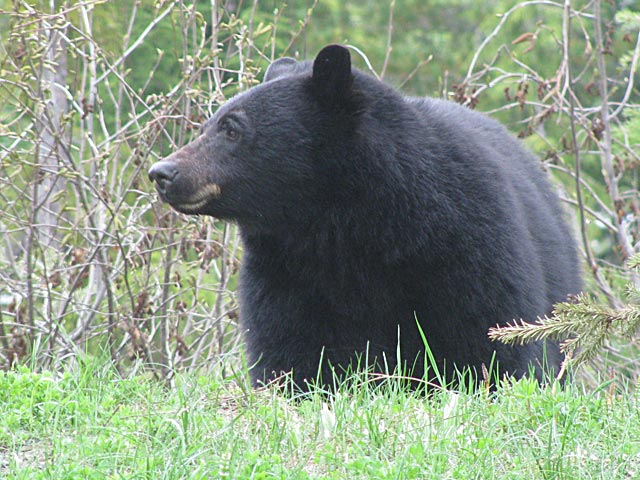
[312,45,353,103]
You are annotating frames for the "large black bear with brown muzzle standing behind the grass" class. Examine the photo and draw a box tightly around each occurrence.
[149,45,581,388]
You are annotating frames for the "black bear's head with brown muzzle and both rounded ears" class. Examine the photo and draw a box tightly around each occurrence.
[149,46,352,232]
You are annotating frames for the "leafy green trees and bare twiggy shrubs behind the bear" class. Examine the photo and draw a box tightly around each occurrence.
[0,0,640,390]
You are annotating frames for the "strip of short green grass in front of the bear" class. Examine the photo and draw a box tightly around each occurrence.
[0,364,640,480]
